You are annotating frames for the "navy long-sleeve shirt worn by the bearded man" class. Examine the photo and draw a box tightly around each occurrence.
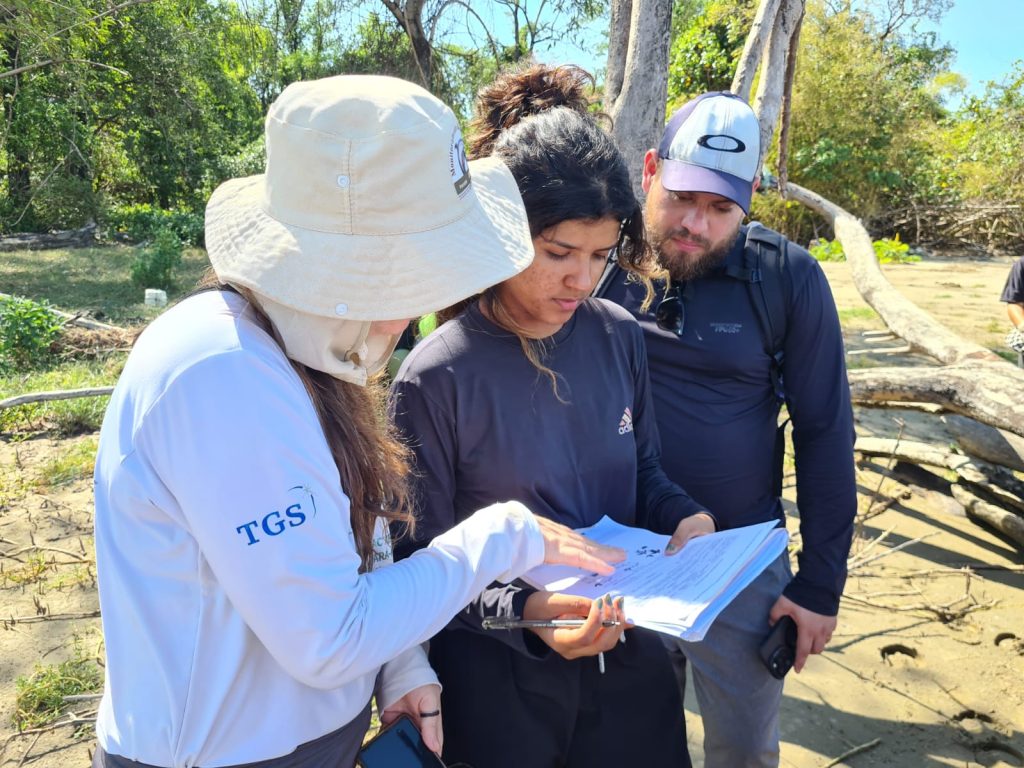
[602,229,857,615]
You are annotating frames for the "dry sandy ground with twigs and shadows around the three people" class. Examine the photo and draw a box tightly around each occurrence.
[0,259,1024,768]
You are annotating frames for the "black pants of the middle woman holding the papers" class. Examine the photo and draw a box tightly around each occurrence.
[430,629,690,768]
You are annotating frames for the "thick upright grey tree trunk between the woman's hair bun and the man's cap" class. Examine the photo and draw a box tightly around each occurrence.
[608,0,672,198]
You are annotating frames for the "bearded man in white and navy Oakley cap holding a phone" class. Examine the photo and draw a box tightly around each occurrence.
[599,92,857,768]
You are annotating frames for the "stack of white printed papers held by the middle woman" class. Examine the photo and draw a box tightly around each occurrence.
[522,517,788,641]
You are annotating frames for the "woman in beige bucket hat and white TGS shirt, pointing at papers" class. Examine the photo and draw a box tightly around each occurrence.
[93,77,622,768]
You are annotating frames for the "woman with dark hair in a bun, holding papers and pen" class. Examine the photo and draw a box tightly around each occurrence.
[391,65,715,768]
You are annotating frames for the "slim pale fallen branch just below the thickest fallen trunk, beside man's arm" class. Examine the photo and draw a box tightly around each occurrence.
[854,437,1024,515]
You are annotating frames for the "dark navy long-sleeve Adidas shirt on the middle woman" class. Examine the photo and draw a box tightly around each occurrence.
[391,299,705,645]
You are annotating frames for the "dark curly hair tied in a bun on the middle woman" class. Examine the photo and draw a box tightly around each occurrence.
[438,63,656,394]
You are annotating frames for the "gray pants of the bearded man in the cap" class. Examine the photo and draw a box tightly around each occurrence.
[662,553,793,768]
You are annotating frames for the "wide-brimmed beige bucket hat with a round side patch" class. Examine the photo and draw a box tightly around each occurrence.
[206,75,534,321]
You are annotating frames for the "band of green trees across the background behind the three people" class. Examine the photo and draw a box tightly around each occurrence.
[0,0,1024,256]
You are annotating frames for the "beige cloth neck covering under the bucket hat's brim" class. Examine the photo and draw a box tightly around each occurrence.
[259,296,400,387]
